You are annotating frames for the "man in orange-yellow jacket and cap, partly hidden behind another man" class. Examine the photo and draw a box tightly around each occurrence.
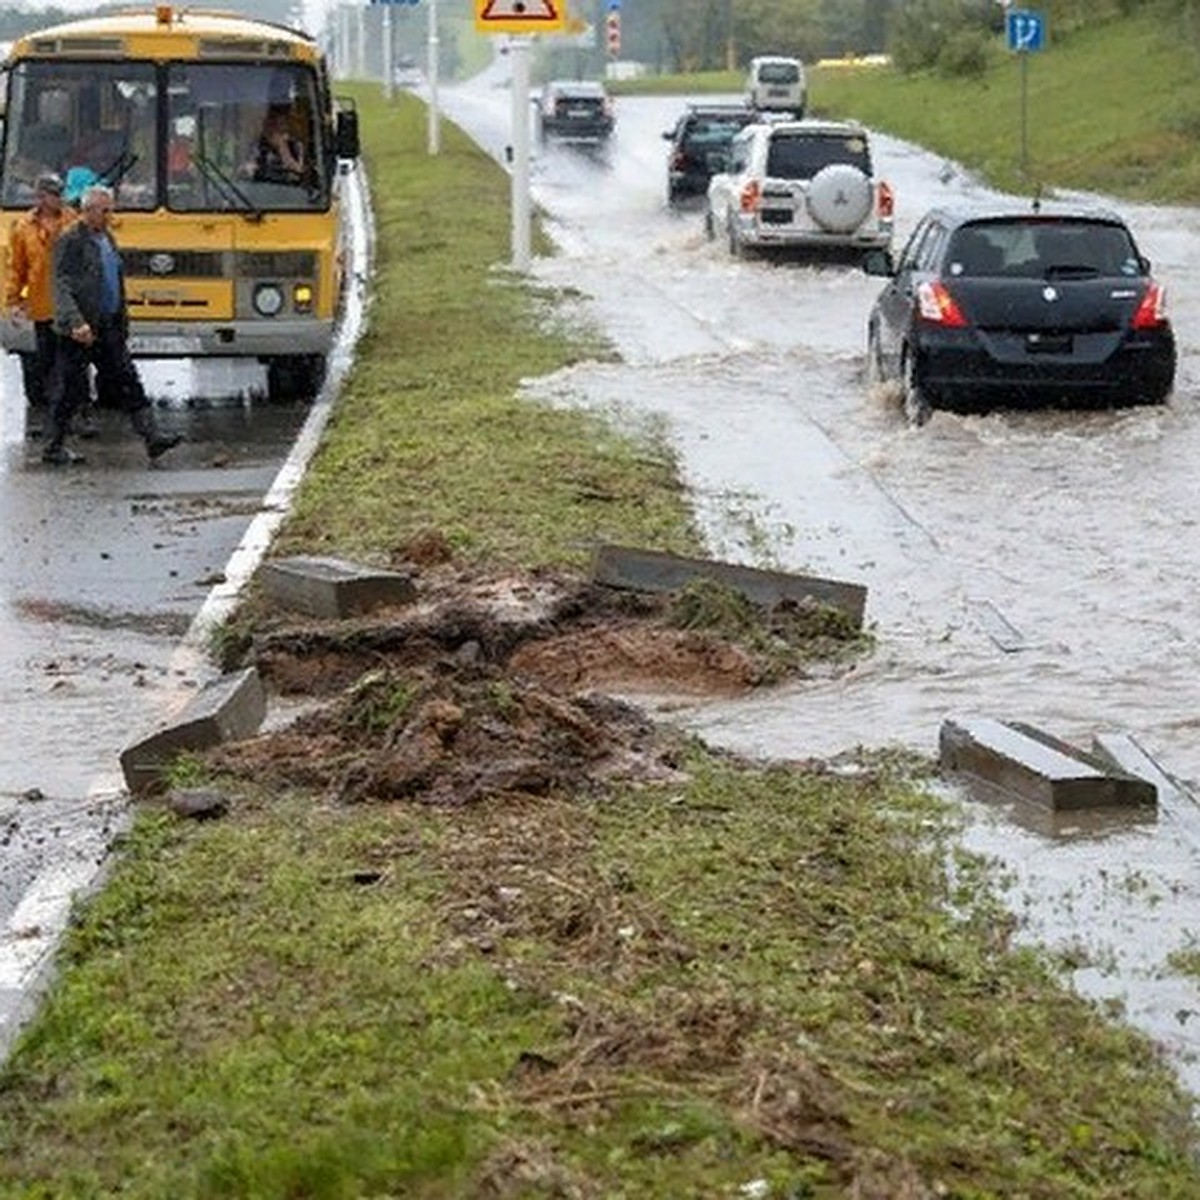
[4,174,78,427]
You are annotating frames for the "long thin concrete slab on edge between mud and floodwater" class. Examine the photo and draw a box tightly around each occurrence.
[592,546,866,629]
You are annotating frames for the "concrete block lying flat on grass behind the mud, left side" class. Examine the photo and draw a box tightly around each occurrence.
[259,554,416,619]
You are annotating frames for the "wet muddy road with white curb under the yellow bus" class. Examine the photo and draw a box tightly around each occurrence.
[0,166,370,1057]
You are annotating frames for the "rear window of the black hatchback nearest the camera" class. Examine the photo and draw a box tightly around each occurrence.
[946,218,1141,278]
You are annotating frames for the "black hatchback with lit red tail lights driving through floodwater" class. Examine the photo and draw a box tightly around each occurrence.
[863,205,1176,424]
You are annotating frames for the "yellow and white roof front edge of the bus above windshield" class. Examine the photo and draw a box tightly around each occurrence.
[8,5,317,59]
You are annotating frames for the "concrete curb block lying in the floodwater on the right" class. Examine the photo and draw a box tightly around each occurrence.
[938,716,1154,811]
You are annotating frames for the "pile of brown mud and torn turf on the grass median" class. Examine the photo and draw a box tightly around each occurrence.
[212,568,857,804]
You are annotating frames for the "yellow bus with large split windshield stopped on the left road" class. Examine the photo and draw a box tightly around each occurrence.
[0,5,359,400]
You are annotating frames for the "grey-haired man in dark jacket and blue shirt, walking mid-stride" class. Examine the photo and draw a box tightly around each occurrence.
[42,185,182,466]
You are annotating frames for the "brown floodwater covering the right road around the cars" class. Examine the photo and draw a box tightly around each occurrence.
[445,70,1200,1093]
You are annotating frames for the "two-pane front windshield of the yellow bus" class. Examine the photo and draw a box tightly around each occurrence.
[0,60,329,214]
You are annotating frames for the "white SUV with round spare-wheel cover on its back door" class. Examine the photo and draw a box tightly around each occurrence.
[704,121,894,254]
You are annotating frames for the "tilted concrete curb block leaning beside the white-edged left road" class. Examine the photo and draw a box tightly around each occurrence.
[121,667,266,793]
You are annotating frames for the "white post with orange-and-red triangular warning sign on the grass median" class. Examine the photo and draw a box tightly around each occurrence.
[475,0,566,271]
